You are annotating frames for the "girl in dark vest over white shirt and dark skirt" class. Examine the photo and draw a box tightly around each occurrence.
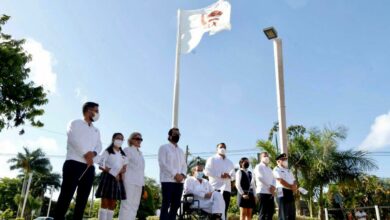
[236,157,255,220]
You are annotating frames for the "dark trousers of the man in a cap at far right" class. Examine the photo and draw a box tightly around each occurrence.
[278,188,295,220]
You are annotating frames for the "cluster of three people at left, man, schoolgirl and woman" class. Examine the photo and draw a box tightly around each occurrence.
[54,102,145,220]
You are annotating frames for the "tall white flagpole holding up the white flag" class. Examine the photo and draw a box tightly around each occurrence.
[172,9,181,128]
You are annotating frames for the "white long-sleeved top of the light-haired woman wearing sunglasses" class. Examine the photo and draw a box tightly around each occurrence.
[123,146,145,186]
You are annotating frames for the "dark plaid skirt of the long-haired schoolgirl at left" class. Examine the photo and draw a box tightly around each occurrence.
[95,172,126,200]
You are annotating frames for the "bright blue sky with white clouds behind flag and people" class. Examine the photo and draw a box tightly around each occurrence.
[0,0,390,197]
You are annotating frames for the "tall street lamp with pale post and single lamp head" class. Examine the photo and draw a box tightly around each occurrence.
[263,27,288,154]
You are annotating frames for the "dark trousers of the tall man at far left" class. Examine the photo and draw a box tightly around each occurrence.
[54,160,95,220]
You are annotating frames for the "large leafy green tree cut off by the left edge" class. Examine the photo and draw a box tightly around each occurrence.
[0,15,48,134]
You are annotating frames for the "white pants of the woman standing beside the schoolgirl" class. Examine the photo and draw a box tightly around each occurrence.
[119,184,142,220]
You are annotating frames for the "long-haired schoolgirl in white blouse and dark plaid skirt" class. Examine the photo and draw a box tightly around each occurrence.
[96,133,127,220]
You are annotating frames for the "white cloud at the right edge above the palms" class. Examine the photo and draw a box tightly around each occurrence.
[359,112,390,151]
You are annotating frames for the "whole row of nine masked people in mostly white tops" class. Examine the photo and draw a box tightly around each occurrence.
[55,102,297,220]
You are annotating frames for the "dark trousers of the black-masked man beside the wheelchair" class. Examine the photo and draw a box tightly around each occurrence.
[160,182,183,220]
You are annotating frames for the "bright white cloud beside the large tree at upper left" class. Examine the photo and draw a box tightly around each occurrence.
[23,38,57,93]
